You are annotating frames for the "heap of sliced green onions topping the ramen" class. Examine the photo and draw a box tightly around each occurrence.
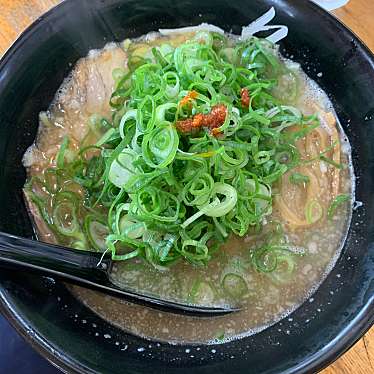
[25,32,319,266]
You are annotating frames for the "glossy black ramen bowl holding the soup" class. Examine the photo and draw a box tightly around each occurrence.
[0,0,374,374]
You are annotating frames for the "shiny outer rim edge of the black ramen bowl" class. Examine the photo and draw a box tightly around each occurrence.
[0,0,374,374]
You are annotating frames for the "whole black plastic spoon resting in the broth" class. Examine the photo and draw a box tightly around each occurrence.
[0,232,239,317]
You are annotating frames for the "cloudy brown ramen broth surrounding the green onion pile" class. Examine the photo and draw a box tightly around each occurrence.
[24,33,354,343]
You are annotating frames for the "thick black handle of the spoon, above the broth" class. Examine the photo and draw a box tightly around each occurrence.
[0,232,110,281]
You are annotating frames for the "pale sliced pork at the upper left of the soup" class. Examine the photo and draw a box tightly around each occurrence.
[24,46,127,175]
